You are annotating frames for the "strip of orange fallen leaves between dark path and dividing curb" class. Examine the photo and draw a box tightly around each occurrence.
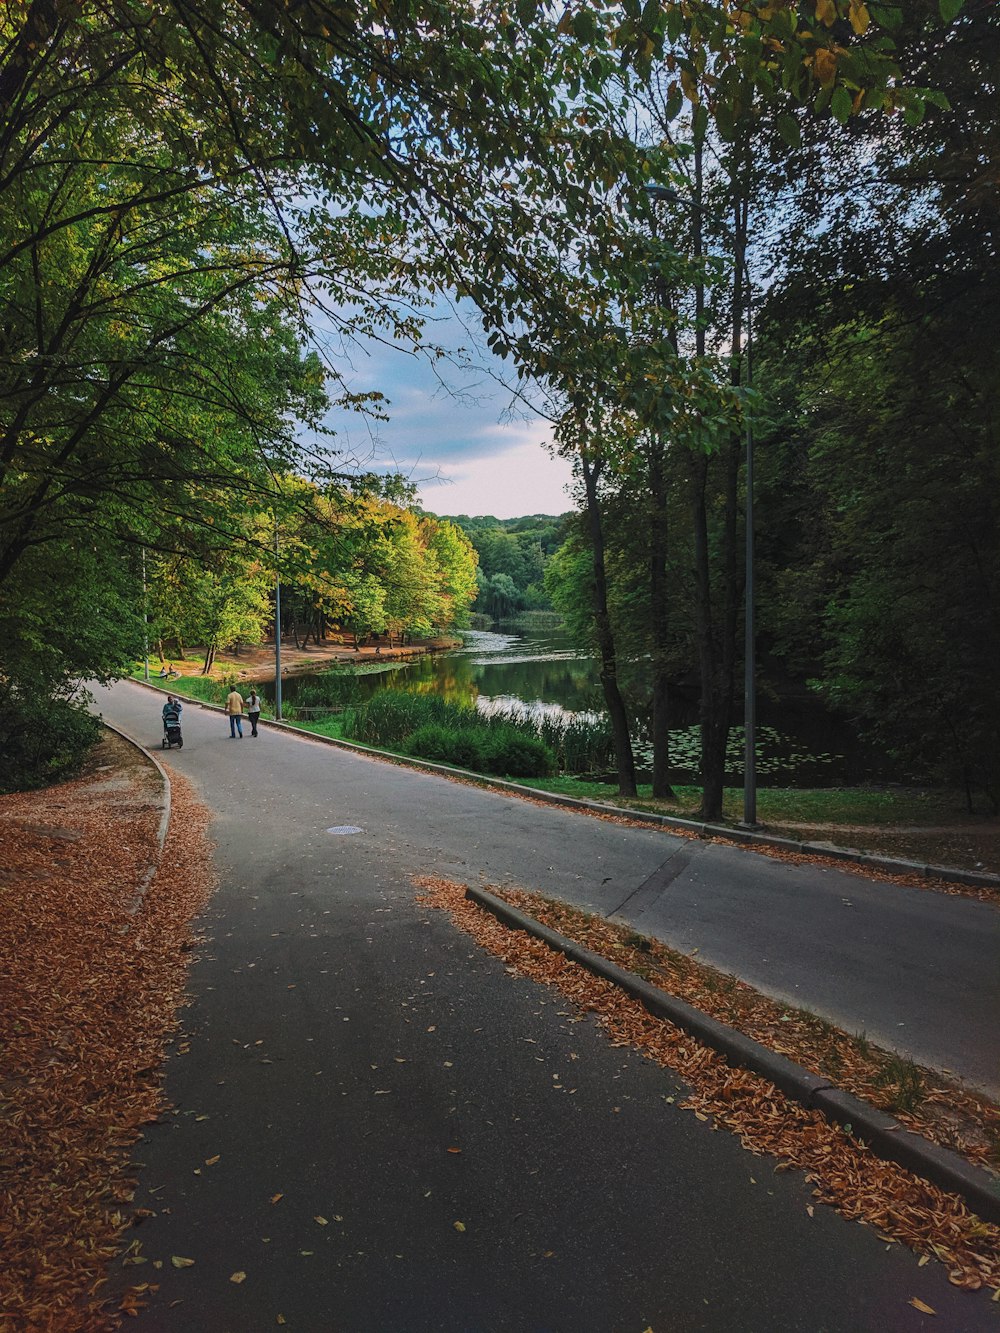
[415,878,1000,1290]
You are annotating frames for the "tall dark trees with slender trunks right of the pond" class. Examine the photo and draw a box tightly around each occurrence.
[536,4,1000,814]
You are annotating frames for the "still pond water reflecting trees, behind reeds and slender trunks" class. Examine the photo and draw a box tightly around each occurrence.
[263,629,873,786]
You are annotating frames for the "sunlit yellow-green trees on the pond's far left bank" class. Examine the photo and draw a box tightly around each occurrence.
[145,476,476,673]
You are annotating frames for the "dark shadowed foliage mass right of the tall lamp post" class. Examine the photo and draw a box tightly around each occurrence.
[759,3,1000,804]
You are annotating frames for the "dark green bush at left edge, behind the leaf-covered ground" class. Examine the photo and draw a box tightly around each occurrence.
[0,696,101,792]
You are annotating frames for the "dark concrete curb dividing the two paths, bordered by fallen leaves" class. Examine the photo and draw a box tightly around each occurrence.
[465,888,1000,1224]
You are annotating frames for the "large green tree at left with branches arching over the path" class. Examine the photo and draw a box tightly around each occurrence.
[0,0,938,789]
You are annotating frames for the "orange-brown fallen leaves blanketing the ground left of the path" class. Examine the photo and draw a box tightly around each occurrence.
[0,737,217,1333]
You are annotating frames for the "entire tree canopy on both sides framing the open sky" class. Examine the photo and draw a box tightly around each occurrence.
[0,0,1000,816]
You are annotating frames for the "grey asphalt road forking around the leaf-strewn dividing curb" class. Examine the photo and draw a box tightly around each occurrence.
[97,684,997,1333]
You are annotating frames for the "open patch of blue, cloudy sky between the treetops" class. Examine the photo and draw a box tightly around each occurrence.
[313,302,573,519]
